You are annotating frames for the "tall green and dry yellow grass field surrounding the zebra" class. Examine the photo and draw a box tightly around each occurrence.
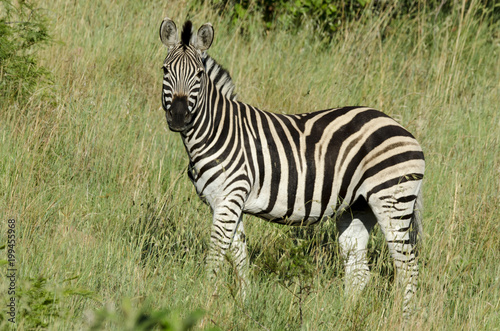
[0,0,500,330]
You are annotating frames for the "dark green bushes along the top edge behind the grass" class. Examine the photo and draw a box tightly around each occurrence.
[202,0,500,40]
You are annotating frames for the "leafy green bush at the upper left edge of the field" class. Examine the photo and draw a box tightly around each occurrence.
[0,0,51,104]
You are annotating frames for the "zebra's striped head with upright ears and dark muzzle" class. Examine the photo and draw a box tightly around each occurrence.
[160,18,214,132]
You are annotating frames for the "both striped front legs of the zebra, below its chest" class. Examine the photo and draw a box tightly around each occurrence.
[207,205,247,296]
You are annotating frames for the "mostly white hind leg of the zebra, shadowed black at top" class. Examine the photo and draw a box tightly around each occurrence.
[337,201,376,297]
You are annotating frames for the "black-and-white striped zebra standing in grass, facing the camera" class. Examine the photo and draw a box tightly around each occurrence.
[160,17,425,312]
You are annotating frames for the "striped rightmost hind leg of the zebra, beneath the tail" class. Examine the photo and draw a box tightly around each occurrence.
[370,182,421,316]
